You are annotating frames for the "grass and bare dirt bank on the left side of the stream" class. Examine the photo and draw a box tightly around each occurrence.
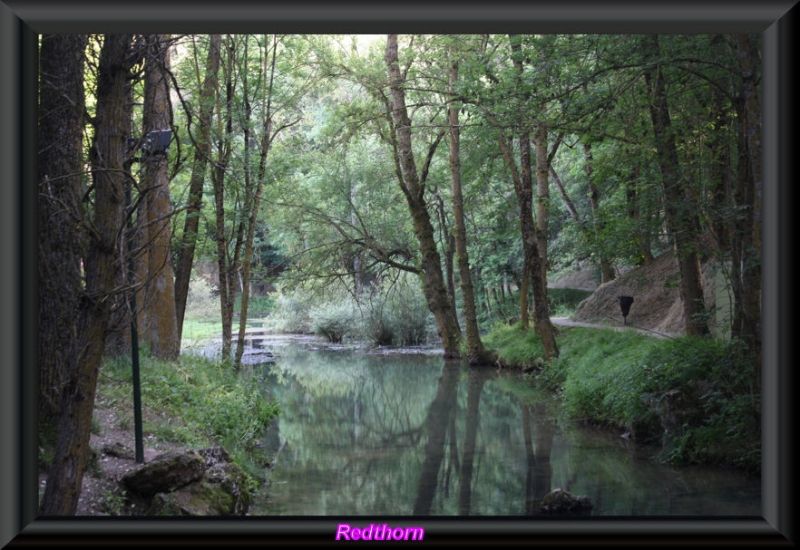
[39,353,279,516]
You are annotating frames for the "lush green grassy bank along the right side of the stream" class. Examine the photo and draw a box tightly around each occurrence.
[485,324,761,473]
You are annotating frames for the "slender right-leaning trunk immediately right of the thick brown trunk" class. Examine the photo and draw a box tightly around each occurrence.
[175,34,222,341]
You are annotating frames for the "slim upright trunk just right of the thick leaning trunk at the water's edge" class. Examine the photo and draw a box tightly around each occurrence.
[447,52,491,365]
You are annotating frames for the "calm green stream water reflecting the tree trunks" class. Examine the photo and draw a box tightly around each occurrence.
[205,334,761,517]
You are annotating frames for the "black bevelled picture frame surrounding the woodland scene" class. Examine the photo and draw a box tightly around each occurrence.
[0,0,797,548]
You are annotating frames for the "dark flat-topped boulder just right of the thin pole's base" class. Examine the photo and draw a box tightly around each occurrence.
[122,451,206,498]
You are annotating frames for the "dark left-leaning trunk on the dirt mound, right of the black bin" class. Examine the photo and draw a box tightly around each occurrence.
[644,35,710,336]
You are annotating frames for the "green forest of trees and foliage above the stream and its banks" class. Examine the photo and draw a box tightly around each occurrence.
[37,34,762,515]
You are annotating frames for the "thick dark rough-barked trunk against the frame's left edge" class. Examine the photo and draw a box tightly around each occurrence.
[37,34,88,433]
